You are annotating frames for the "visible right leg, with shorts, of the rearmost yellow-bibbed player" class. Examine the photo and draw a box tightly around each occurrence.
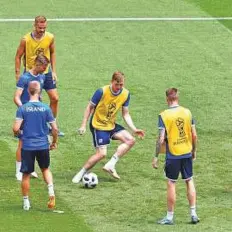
[44,72,64,136]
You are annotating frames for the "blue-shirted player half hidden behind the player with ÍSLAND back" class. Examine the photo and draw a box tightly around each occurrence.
[14,55,49,181]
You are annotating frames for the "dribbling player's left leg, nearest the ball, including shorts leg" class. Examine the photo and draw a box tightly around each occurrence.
[72,125,110,184]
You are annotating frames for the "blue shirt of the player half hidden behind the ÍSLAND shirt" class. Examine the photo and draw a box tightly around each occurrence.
[16,72,45,104]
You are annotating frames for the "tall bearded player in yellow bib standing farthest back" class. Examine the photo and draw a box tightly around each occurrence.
[15,16,64,136]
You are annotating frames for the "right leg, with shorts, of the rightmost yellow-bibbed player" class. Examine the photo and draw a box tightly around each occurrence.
[181,158,200,224]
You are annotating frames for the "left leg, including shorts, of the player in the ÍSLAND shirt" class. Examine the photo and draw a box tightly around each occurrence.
[20,149,35,210]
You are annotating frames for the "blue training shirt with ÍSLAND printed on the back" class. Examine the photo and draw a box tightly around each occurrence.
[16,101,55,150]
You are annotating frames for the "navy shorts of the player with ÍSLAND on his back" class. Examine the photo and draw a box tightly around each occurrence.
[20,149,50,173]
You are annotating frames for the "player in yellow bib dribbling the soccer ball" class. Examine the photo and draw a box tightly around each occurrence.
[72,71,144,183]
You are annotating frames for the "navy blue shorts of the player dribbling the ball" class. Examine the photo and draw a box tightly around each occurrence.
[90,123,125,147]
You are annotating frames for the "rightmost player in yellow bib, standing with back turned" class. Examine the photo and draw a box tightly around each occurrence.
[152,88,199,225]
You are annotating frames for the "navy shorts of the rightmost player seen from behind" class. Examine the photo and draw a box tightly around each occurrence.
[164,157,193,181]
